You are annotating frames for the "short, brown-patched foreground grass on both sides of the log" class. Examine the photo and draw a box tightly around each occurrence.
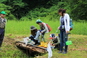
[0,34,87,58]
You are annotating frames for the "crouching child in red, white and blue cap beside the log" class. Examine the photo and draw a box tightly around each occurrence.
[49,34,60,50]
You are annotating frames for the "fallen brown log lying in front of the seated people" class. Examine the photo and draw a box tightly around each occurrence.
[15,41,47,53]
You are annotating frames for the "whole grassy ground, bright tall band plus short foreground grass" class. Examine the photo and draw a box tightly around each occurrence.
[0,20,87,58]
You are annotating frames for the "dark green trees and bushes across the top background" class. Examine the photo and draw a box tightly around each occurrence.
[0,0,87,20]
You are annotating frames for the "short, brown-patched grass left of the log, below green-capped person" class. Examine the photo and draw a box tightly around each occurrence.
[0,36,32,58]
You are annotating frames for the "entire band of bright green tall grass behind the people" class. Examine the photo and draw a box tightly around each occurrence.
[6,20,87,35]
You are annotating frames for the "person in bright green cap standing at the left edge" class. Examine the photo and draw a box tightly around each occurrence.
[0,11,6,47]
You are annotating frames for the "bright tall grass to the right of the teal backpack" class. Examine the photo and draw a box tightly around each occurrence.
[71,21,87,35]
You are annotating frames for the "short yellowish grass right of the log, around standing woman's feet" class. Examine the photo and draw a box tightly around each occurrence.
[37,35,87,58]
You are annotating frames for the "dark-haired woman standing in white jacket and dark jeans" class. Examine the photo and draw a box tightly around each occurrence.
[58,9,70,54]
